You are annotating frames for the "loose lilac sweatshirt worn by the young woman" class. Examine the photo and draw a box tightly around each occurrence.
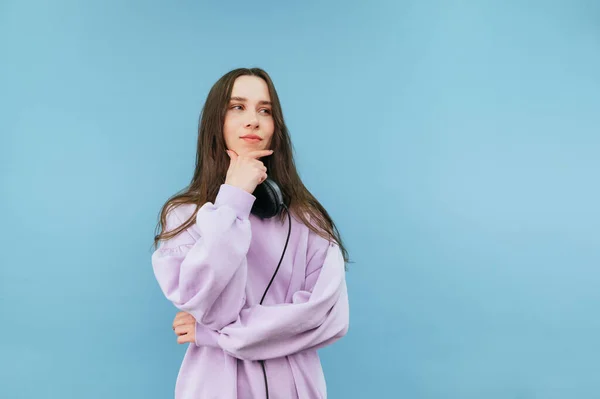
[152,184,349,399]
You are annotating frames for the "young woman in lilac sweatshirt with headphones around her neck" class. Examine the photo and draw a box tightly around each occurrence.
[152,68,349,399]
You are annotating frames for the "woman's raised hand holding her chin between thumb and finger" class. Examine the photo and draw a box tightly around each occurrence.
[225,150,273,194]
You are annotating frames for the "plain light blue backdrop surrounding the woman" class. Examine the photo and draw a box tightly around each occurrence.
[0,0,600,399]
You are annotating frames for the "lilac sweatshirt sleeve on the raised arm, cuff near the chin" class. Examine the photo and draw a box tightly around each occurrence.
[152,184,255,330]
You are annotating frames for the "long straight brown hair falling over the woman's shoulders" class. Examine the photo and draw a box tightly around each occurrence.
[154,68,348,262]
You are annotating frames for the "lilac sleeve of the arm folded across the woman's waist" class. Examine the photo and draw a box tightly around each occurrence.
[217,234,349,360]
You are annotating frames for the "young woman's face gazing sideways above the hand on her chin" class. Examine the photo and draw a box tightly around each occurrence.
[223,76,275,155]
